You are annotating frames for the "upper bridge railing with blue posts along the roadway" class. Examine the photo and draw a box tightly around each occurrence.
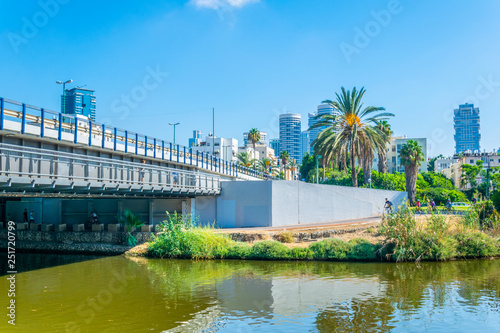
[0,97,275,179]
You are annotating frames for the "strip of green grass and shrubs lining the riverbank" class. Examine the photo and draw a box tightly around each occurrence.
[148,207,500,261]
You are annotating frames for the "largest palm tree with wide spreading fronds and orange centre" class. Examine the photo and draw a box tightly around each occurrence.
[309,87,394,187]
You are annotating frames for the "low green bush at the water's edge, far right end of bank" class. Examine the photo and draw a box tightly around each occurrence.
[455,231,500,257]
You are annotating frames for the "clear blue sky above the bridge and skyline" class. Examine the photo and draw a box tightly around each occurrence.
[0,0,500,156]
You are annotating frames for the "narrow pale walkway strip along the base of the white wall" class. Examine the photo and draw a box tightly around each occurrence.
[216,216,382,233]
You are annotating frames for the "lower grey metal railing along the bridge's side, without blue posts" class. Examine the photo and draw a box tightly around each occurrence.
[0,144,221,192]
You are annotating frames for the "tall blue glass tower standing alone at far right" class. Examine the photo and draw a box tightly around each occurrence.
[453,104,481,154]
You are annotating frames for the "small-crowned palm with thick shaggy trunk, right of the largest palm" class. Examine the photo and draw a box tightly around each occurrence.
[399,140,424,205]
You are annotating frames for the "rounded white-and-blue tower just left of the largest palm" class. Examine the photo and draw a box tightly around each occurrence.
[276,113,302,164]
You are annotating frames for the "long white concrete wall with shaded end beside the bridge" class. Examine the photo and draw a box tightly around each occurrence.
[216,181,407,228]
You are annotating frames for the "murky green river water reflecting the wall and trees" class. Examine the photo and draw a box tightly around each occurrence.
[0,254,500,333]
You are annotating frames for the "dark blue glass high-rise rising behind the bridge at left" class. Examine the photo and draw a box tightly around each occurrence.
[61,87,96,121]
